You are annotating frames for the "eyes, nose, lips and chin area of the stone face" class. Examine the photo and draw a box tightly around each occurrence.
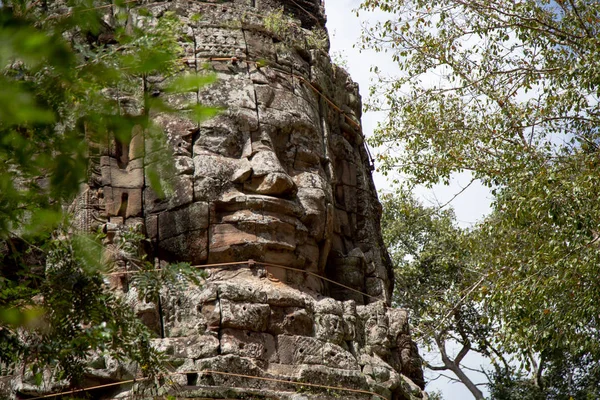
[193,101,332,271]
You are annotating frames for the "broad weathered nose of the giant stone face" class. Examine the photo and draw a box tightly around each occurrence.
[244,148,297,196]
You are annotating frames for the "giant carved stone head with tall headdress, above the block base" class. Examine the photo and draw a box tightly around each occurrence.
[84,5,392,303]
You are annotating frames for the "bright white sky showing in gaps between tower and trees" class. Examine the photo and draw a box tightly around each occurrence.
[325,0,490,400]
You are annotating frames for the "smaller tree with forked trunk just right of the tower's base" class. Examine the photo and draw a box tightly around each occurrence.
[381,190,506,399]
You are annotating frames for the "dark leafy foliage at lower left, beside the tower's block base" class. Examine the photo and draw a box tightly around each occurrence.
[0,233,162,382]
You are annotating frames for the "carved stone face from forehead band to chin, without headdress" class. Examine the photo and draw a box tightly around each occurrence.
[145,62,334,288]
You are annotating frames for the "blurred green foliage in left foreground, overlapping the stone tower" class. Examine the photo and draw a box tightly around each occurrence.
[0,0,215,394]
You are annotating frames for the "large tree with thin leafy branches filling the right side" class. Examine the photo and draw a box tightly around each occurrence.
[362,0,600,396]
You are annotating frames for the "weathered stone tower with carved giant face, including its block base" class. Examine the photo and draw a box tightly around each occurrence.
[28,0,427,400]
